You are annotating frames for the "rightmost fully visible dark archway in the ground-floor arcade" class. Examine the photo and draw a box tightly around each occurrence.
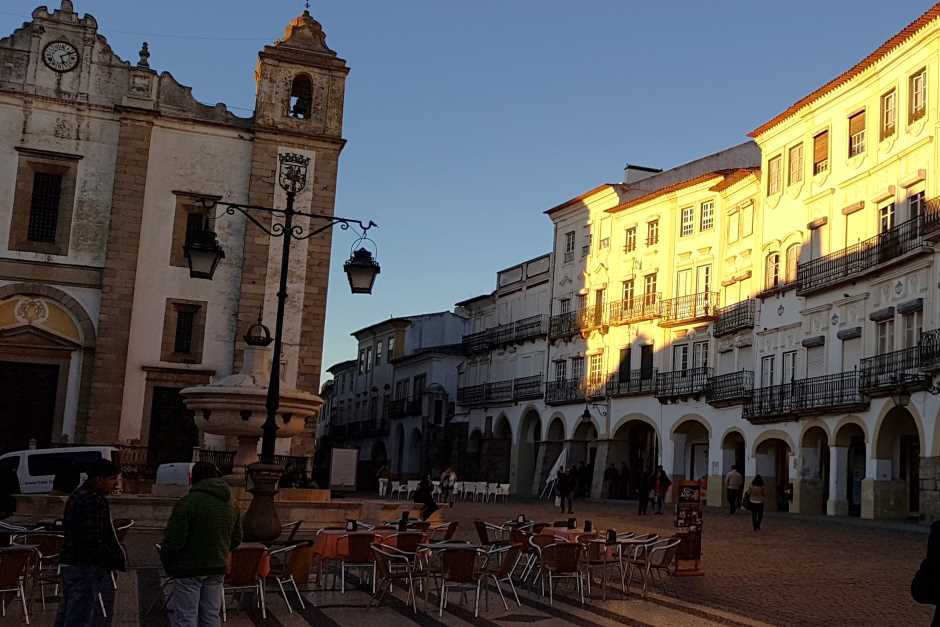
[872,407,920,518]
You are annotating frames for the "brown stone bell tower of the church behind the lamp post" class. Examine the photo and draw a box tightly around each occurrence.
[233,11,349,412]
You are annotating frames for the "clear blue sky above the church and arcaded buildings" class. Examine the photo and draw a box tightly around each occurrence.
[0,0,930,382]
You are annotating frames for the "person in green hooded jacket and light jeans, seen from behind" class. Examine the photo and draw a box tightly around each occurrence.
[160,462,242,627]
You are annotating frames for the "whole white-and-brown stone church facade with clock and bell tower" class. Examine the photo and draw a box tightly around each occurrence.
[0,0,349,462]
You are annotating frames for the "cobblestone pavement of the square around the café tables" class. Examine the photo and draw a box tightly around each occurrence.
[11,501,931,627]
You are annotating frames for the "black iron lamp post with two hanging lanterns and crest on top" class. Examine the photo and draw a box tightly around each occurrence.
[183,153,380,541]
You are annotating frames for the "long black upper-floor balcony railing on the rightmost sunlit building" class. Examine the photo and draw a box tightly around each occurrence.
[796,215,938,295]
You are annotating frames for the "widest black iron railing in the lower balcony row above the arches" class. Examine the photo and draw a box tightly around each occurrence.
[742,370,868,423]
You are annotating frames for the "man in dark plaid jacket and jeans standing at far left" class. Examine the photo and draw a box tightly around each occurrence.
[55,459,127,627]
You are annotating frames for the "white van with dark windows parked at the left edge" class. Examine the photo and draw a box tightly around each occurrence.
[0,446,119,494]
